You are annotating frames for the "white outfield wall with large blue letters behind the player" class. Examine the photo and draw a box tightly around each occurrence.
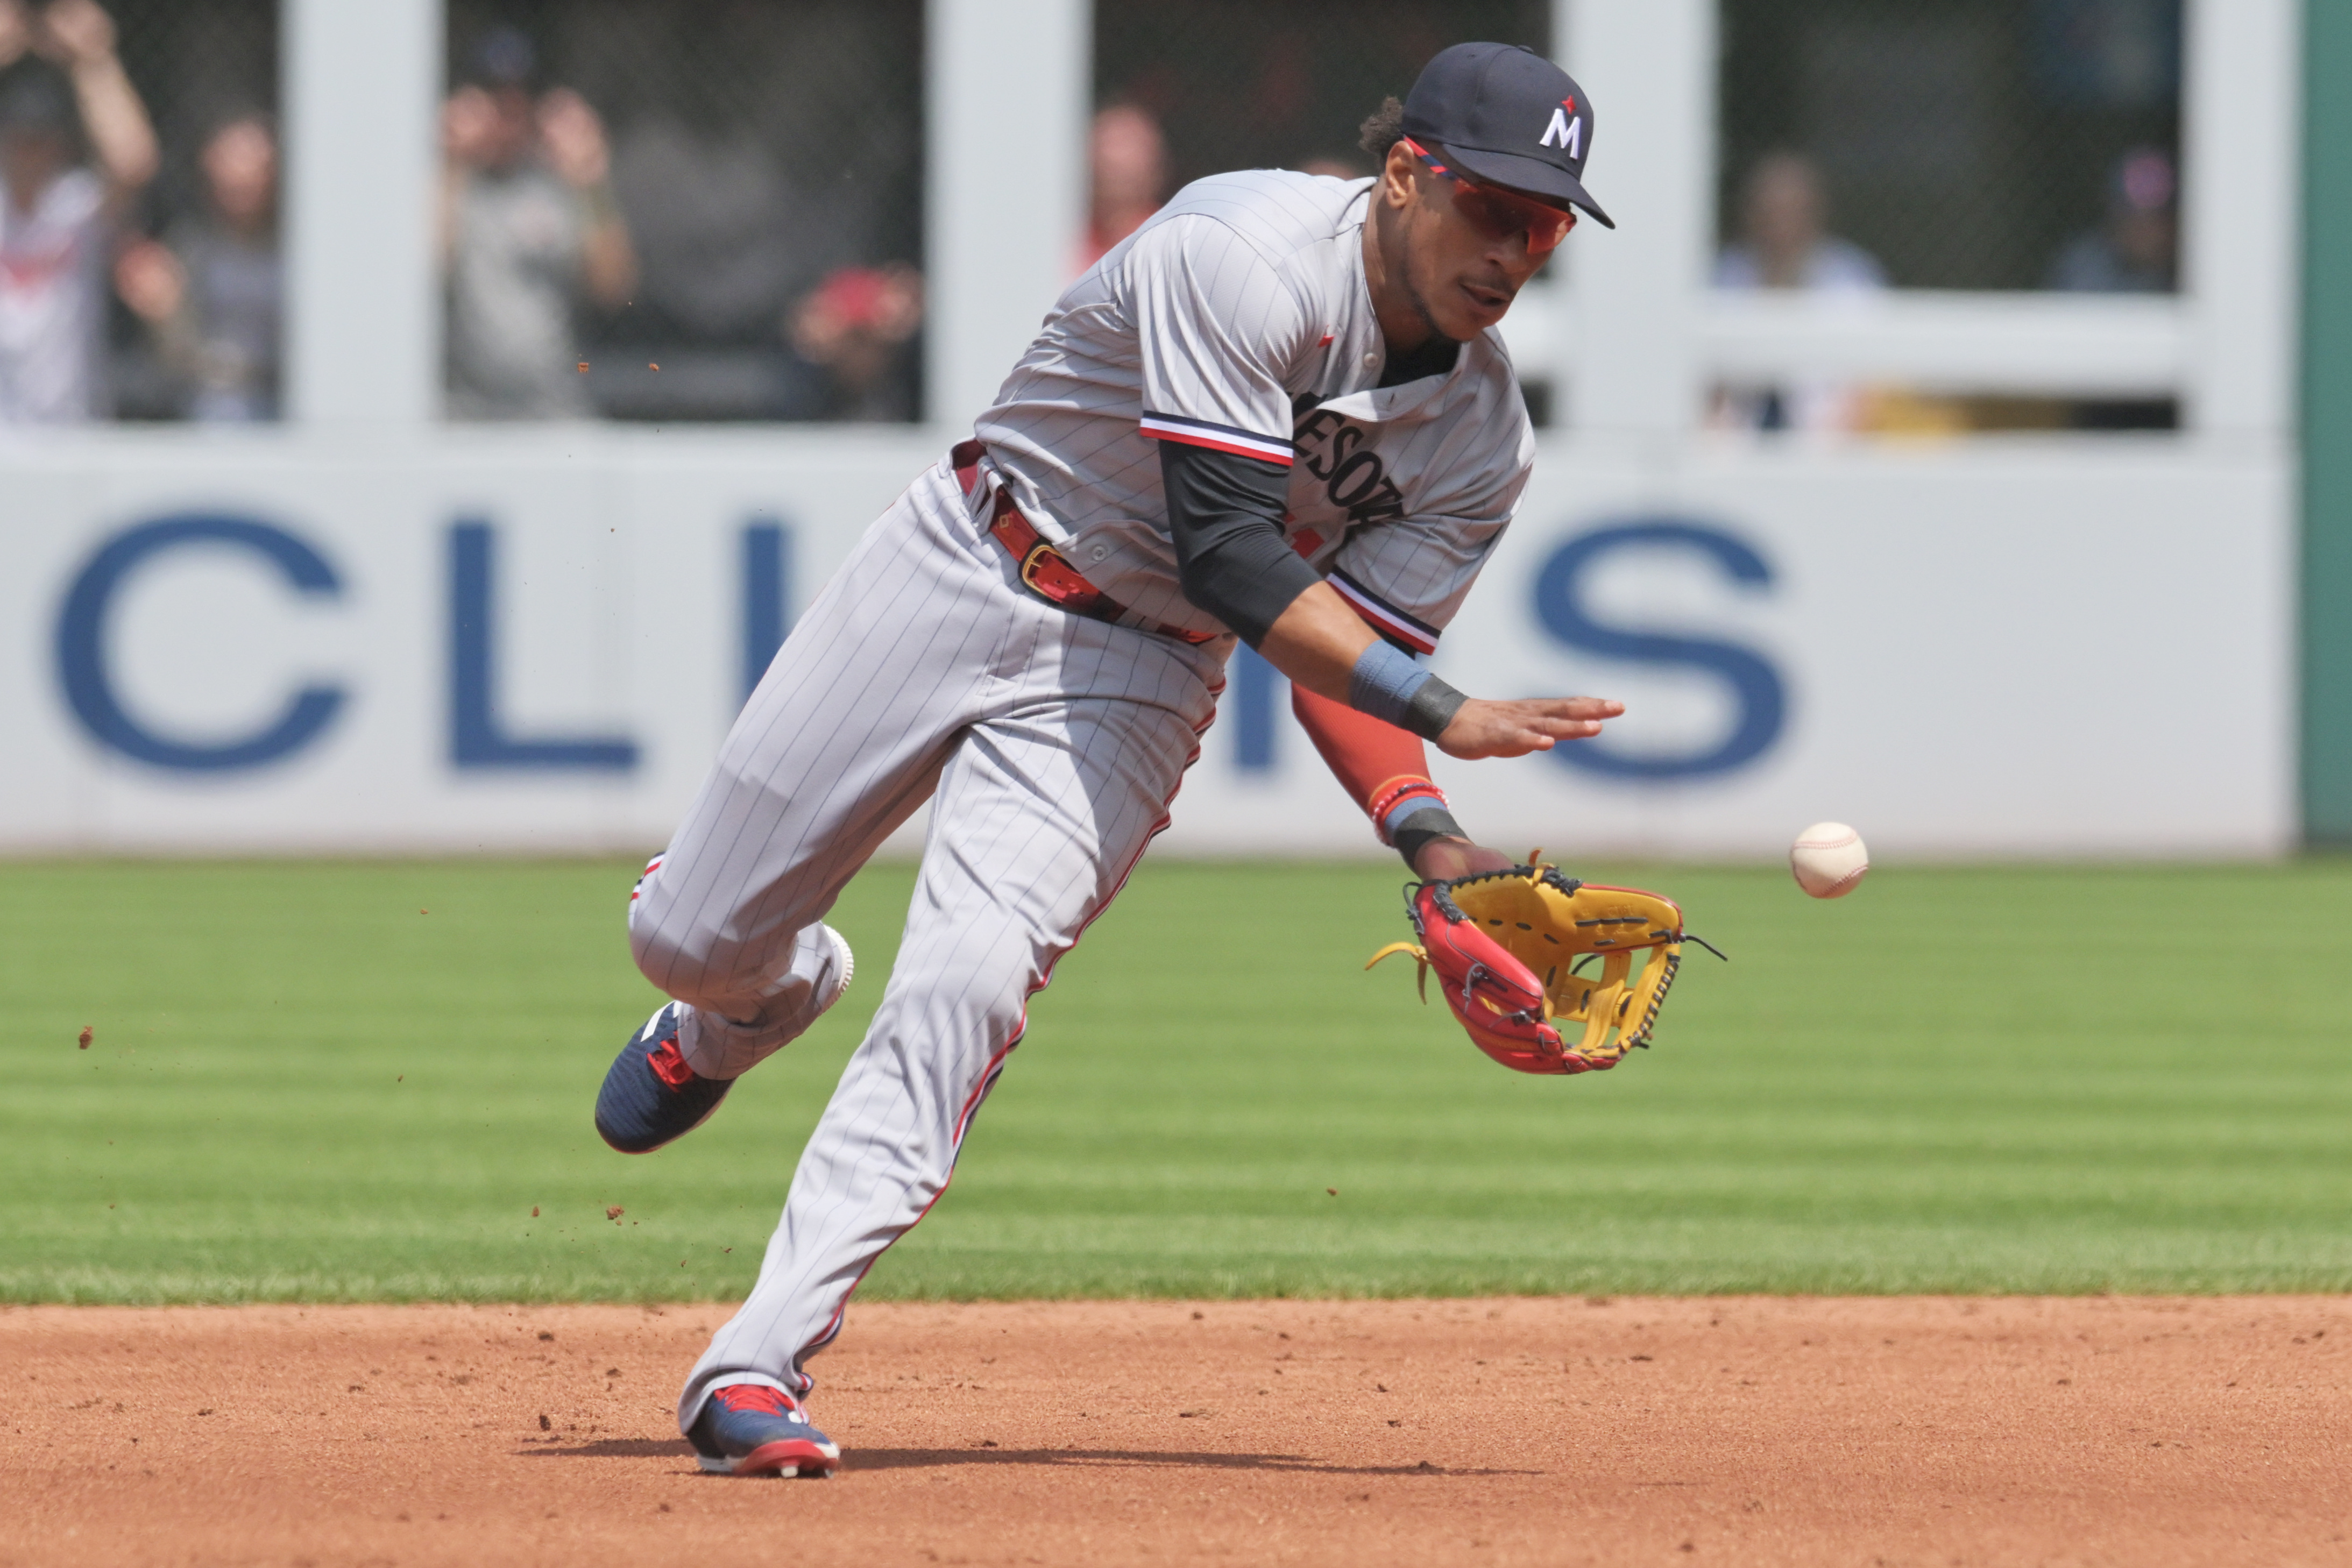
[0,430,2296,858]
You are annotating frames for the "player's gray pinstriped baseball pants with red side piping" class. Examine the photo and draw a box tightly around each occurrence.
[630,463,1230,1427]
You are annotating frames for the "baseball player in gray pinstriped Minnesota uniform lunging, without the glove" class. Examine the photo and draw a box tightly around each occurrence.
[597,45,1620,1474]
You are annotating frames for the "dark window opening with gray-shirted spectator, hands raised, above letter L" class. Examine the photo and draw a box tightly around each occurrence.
[440,0,924,423]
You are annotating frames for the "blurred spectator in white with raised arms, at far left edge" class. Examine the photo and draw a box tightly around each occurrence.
[0,0,155,423]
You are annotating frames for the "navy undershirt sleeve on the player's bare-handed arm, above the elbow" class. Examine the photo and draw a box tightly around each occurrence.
[1159,442,1322,647]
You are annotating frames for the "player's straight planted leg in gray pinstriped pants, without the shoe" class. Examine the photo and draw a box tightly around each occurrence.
[677,621,1221,1457]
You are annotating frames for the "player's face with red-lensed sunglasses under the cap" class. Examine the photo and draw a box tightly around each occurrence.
[1383,144,1576,341]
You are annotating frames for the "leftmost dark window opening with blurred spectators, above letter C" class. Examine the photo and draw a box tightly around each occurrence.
[0,0,285,425]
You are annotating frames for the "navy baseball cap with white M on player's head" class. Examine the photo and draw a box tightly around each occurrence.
[1404,45,1616,228]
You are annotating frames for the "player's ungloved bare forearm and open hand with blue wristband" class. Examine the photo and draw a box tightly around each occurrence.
[1258,583,1625,757]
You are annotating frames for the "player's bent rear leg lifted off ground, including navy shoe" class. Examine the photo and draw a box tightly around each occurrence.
[597,456,1004,1152]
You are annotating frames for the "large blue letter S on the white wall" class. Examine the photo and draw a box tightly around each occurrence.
[1536,517,1788,778]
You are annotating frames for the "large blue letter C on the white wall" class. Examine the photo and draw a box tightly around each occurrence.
[56,513,346,774]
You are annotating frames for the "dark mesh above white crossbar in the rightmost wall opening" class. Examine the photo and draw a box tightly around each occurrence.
[1717,0,2180,292]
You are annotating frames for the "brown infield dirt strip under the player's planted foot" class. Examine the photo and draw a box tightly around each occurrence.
[0,1295,2352,1568]
